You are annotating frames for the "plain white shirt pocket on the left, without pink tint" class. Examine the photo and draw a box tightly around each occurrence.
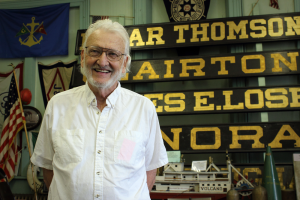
[54,129,84,163]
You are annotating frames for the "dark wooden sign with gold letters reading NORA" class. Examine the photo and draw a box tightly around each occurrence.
[161,122,300,153]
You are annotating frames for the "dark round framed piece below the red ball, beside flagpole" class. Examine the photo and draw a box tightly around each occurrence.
[23,106,43,131]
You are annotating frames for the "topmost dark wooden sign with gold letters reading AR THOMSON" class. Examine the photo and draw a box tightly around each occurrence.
[75,13,300,55]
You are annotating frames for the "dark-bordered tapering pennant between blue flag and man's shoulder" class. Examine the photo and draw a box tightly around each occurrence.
[38,60,77,107]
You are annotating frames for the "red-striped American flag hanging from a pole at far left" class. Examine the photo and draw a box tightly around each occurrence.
[0,76,25,181]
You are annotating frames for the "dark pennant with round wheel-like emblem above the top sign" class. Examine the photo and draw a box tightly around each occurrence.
[164,0,210,22]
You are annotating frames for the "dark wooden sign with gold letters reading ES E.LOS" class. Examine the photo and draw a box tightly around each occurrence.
[143,86,300,115]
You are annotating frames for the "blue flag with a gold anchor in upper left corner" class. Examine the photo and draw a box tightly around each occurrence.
[0,3,70,58]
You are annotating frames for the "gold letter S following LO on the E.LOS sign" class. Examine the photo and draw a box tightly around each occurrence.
[265,88,289,108]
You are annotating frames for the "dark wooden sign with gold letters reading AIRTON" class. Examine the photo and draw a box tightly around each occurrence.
[122,50,300,83]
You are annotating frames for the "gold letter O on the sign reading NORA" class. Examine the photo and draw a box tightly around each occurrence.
[191,127,221,150]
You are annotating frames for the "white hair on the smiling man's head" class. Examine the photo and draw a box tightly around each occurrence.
[83,19,131,73]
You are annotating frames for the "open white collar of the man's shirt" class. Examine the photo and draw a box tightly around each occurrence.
[84,81,121,108]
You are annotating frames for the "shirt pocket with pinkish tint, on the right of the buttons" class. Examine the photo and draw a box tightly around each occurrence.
[114,131,145,166]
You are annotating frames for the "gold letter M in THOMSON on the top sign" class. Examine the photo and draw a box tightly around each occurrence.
[227,20,249,40]
